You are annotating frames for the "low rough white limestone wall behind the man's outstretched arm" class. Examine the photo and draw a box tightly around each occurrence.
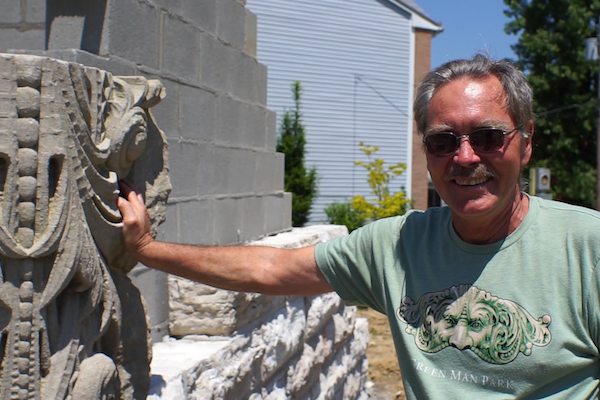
[148,226,368,400]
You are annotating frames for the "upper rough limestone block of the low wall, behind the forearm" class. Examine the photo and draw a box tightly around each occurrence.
[169,225,348,337]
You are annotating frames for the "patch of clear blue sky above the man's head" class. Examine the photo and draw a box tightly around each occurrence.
[415,0,518,68]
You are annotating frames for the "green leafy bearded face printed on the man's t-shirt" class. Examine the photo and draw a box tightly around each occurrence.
[397,285,552,364]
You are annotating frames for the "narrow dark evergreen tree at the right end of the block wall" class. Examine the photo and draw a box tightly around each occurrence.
[277,82,317,226]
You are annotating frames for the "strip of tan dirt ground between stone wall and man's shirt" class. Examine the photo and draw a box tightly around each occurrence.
[358,308,406,400]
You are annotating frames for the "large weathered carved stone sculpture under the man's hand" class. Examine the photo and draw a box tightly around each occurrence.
[0,54,170,400]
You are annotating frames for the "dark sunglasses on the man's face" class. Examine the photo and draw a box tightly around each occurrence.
[423,127,520,157]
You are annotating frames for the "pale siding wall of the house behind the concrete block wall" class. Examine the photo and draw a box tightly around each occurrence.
[247,0,441,223]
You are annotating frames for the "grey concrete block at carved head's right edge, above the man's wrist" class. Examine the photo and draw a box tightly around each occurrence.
[167,138,200,199]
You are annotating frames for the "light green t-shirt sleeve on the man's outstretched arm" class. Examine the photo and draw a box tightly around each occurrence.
[315,217,402,313]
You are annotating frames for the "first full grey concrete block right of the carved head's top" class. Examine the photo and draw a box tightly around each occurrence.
[179,85,218,141]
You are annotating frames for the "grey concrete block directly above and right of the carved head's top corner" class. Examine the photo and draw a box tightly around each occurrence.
[160,15,200,82]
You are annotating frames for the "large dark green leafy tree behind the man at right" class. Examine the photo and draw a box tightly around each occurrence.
[504,0,600,207]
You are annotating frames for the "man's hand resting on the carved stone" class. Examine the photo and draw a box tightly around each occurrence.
[117,181,154,259]
